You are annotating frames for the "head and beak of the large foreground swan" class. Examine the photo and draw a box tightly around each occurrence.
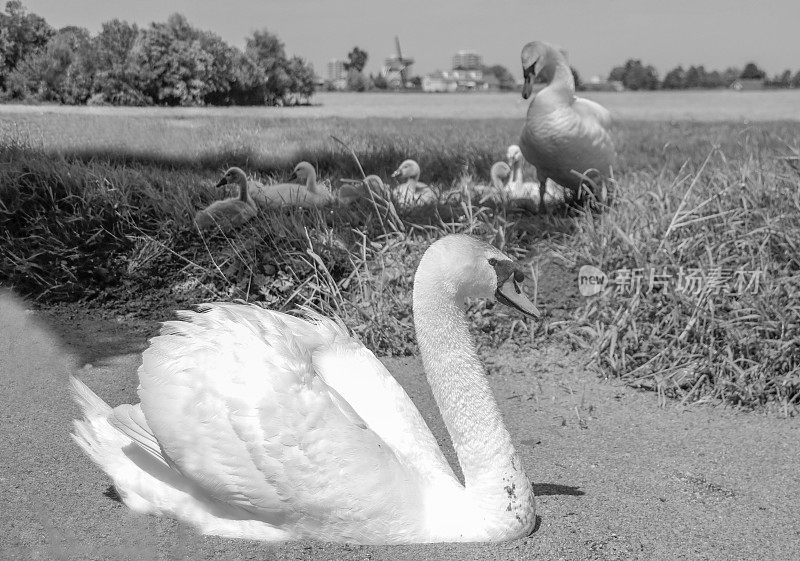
[414,234,541,317]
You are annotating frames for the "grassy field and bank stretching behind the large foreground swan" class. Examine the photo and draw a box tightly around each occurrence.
[0,92,800,414]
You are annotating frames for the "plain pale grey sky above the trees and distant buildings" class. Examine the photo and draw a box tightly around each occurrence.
[18,0,800,79]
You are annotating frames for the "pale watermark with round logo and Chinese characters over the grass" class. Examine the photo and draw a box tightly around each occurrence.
[578,265,764,297]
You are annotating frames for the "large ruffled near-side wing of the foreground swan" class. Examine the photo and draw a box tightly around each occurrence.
[139,304,419,527]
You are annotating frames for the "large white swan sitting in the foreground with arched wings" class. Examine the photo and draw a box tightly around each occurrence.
[71,235,538,543]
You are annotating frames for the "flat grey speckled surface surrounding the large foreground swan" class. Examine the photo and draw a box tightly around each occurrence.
[0,293,800,560]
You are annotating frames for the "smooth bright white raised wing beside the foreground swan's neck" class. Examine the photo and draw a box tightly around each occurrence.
[313,337,455,478]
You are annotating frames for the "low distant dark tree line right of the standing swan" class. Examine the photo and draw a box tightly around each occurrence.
[608,59,800,90]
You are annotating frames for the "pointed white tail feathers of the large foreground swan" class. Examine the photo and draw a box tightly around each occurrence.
[70,376,292,541]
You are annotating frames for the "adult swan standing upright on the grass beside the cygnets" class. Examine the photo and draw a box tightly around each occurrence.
[520,41,616,207]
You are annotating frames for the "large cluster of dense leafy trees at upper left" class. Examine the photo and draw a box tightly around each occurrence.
[0,0,314,106]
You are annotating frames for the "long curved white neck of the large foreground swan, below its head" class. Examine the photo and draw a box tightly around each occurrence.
[414,270,533,531]
